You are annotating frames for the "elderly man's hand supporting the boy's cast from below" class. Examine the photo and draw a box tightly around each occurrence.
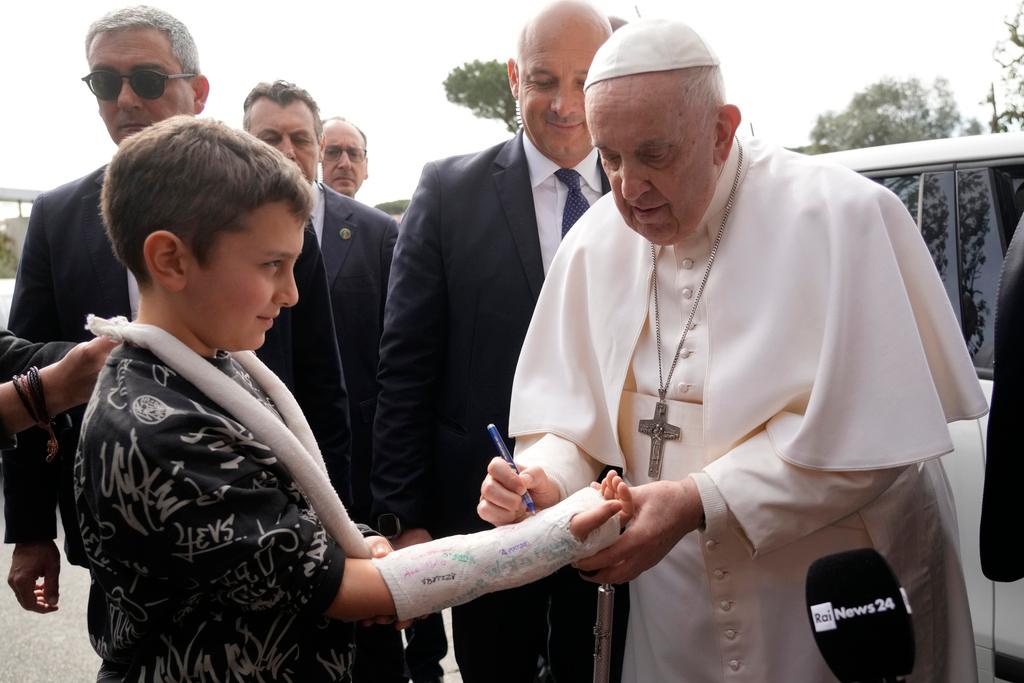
[575,477,703,584]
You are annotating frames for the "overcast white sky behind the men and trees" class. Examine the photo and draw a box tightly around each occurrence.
[0,0,1019,204]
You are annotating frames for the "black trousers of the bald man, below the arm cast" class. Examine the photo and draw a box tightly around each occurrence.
[452,566,629,683]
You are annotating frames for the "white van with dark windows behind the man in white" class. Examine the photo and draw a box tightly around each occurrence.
[820,133,1024,683]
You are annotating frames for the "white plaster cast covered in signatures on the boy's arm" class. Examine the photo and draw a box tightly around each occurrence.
[374,487,620,621]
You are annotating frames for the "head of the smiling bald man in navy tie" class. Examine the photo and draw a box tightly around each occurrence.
[508,0,611,168]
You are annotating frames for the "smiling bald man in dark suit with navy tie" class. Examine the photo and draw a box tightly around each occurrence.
[372,2,625,683]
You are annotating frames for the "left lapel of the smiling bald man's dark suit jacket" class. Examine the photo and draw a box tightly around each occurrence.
[494,131,544,301]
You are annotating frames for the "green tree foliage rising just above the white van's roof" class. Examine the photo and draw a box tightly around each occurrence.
[805,78,980,154]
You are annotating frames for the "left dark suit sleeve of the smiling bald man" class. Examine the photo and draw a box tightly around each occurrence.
[371,164,447,528]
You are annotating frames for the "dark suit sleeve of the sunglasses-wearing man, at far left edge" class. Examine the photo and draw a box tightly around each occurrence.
[3,195,67,543]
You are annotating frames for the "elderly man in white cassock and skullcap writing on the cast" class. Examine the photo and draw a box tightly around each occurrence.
[478,15,986,683]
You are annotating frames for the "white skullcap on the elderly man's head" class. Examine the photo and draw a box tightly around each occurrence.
[584,19,719,89]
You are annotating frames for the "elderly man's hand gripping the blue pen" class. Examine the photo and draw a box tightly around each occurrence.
[476,458,561,526]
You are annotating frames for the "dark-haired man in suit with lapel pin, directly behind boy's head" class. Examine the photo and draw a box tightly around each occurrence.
[243,81,419,683]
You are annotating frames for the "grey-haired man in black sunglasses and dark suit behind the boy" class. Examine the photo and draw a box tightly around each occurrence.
[3,7,349,634]
